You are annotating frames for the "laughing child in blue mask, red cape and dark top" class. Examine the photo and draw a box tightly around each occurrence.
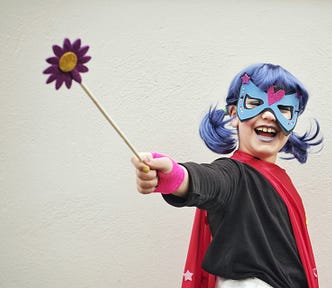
[132,64,322,288]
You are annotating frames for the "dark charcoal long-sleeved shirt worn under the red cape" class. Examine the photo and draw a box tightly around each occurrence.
[163,158,308,288]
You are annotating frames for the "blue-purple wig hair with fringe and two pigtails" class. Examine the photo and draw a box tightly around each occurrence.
[199,63,323,163]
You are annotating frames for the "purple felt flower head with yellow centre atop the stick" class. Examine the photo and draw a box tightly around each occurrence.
[43,38,91,90]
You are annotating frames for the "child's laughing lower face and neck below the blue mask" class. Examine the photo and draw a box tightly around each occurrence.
[232,106,289,163]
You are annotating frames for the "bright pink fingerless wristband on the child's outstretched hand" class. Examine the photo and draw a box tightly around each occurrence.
[152,153,184,194]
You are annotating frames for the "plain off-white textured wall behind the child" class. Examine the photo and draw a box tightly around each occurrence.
[0,0,332,288]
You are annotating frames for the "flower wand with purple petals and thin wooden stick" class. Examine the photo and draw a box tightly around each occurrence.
[43,38,148,172]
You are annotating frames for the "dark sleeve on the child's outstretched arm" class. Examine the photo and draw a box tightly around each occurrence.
[163,158,240,210]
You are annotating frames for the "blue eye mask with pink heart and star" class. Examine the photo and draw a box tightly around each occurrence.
[237,74,300,135]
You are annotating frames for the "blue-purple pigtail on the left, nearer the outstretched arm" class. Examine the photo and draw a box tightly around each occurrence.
[199,107,237,154]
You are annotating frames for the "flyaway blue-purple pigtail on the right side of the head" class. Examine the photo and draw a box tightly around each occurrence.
[281,120,323,164]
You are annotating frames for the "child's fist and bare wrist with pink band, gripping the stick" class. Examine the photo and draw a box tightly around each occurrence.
[131,153,189,198]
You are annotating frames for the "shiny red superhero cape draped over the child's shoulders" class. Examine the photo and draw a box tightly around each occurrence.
[182,151,319,288]
